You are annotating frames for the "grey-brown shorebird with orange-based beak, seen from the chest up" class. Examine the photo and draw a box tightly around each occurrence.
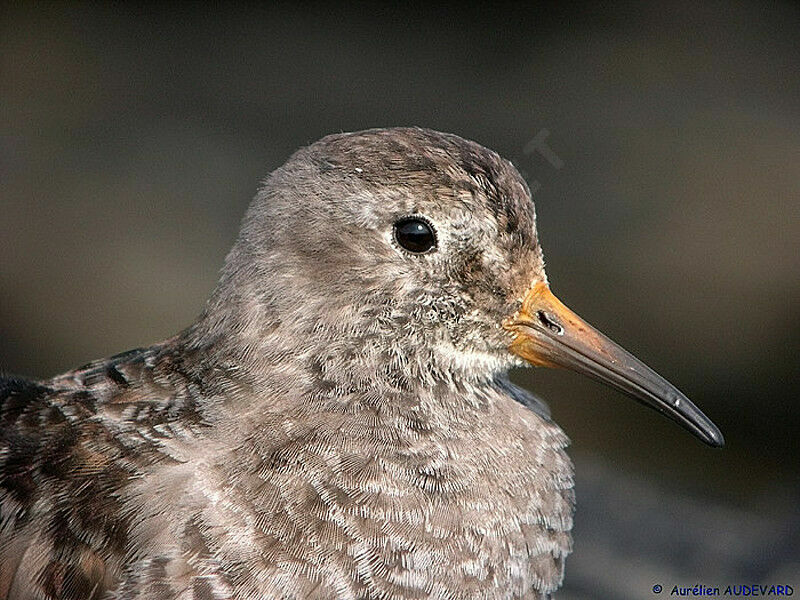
[0,127,723,600]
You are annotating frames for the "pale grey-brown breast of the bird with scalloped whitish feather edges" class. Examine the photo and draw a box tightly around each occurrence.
[123,382,573,598]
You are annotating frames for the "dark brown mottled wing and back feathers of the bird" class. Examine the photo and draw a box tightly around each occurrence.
[0,340,219,600]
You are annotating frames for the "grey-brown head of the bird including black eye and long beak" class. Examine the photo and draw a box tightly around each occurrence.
[209,128,722,446]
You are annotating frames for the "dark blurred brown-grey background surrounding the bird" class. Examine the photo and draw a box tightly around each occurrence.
[0,2,800,600]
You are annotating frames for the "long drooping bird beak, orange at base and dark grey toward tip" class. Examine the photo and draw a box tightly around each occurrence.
[503,283,725,447]
